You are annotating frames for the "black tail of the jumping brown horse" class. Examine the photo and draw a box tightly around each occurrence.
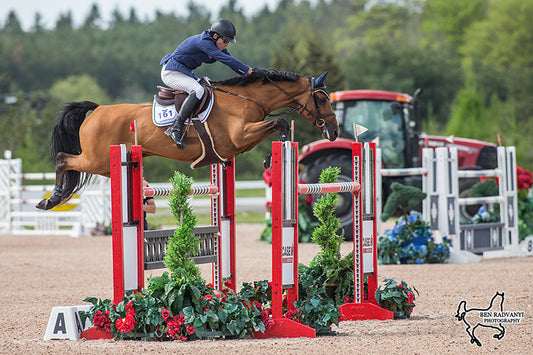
[51,101,98,201]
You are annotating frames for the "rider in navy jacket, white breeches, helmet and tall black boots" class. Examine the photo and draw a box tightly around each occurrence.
[159,19,252,149]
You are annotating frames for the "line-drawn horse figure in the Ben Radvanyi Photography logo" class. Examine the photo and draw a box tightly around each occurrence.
[455,292,505,346]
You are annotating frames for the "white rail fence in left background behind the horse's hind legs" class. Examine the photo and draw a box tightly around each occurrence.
[0,151,267,237]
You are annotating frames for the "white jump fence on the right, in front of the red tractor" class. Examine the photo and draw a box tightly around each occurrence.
[376,147,519,256]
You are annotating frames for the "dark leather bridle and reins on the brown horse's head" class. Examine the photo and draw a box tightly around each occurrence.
[211,77,335,129]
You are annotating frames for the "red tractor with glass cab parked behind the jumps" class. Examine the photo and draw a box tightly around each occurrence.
[300,89,497,238]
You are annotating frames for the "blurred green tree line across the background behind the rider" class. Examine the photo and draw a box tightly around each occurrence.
[0,0,533,181]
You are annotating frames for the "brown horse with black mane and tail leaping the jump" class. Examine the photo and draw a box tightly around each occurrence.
[36,69,339,210]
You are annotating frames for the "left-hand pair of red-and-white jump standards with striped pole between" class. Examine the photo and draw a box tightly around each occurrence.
[110,145,236,304]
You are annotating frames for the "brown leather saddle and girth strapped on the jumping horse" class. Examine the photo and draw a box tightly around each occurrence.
[155,84,227,169]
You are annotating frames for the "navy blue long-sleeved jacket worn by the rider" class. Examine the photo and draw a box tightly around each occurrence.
[159,31,250,79]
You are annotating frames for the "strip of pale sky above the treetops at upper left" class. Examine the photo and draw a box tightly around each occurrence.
[0,0,279,30]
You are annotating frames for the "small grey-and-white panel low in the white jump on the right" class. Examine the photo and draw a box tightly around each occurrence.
[460,223,504,254]
